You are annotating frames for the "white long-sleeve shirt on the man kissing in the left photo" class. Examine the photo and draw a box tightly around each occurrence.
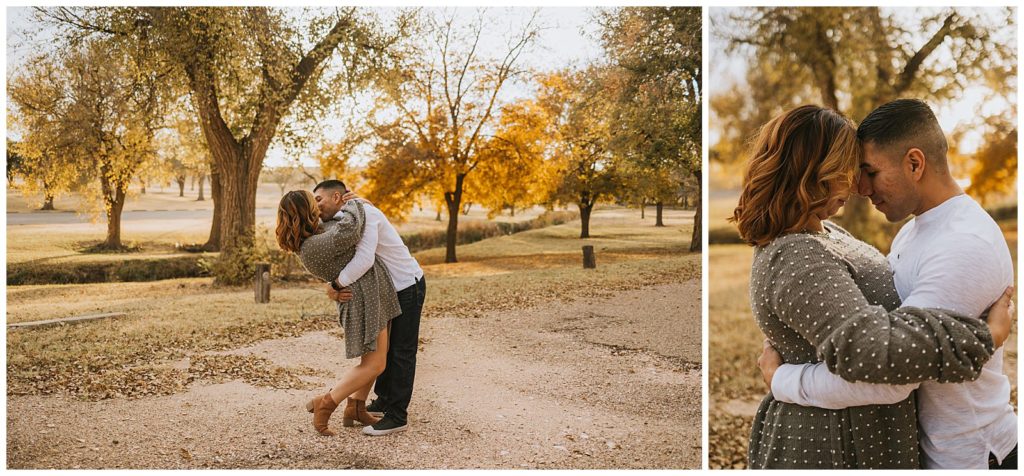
[338,201,423,291]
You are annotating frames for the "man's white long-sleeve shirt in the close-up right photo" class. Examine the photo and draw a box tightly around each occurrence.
[772,194,1017,469]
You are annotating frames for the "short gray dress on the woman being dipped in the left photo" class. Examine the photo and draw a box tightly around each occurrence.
[299,200,401,358]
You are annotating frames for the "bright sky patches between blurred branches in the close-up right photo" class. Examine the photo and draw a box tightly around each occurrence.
[706,8,1017,153]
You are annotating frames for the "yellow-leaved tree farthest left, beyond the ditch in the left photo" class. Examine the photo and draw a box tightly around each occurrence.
[11,39,164,250]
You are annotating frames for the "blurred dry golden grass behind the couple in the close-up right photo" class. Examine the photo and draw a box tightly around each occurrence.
[708,220,1017,469]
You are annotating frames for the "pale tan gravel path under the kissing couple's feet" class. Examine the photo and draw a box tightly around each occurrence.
[7,279,701,469]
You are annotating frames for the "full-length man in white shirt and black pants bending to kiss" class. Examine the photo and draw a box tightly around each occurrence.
[313,180,427,436]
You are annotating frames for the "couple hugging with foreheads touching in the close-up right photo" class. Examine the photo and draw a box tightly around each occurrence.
[732,99,1017,469]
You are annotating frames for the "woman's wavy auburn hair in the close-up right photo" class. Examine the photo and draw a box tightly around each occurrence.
[729,105,860,246]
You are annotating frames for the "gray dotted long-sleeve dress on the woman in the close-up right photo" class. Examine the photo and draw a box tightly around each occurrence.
[748,222,993,468]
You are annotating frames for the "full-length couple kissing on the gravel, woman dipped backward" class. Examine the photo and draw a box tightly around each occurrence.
[276,180,427,436]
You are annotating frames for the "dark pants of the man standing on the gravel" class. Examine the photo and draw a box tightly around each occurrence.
[374,277,427,425]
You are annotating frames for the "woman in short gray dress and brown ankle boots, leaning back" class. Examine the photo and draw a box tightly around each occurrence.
[276,190,401,436]
